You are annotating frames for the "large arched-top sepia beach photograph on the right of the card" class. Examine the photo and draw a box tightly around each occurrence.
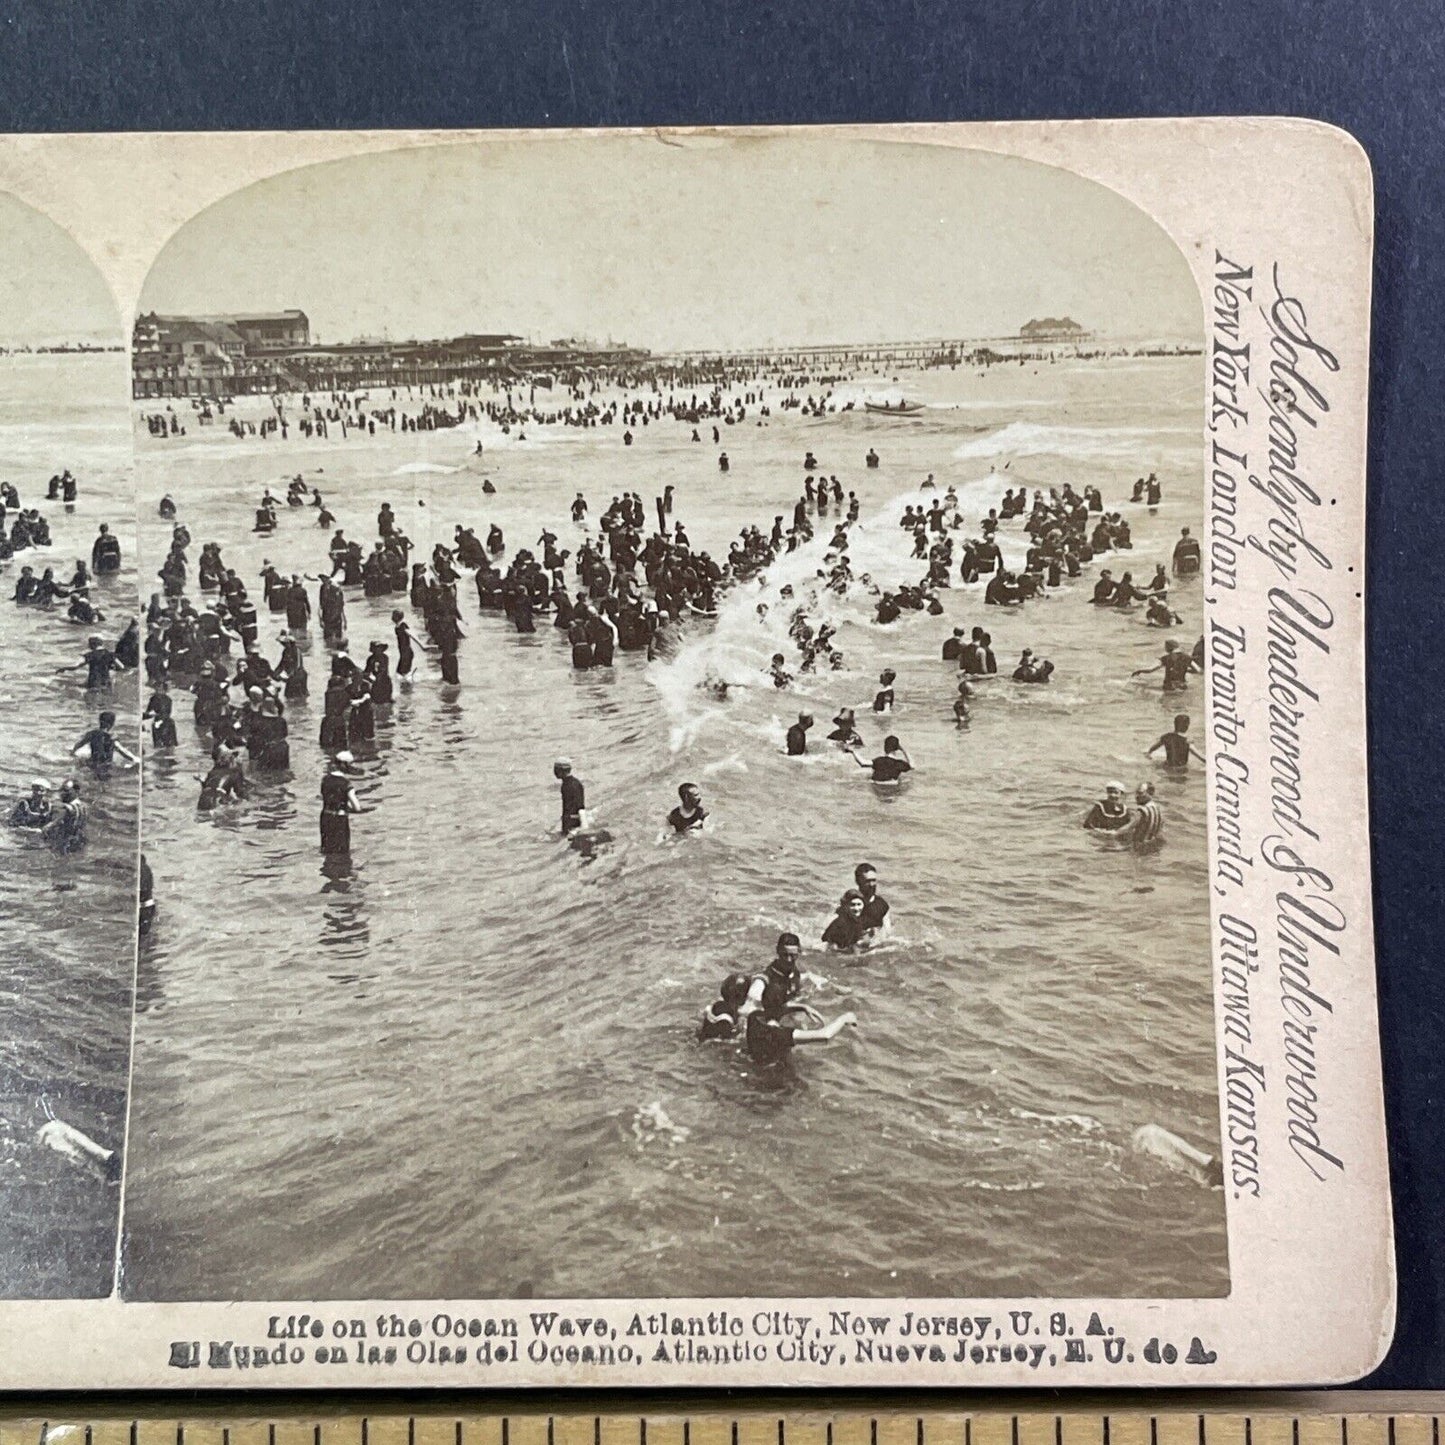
[115,131,1231,1301]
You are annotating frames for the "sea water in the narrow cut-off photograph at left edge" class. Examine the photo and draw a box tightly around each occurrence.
[0,354,140,1298]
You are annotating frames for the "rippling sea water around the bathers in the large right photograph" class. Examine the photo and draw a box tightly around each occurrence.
[123,349,1228,1299]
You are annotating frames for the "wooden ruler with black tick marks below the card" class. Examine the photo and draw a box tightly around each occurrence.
[0,1392,1445,1445]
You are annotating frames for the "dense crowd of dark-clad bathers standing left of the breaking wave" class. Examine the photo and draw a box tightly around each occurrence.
[135,412,890,878]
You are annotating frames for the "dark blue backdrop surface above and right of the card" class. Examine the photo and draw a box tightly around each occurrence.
[0,0,1445,1389]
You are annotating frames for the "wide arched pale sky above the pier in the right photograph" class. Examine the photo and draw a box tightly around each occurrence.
[142,134,1201,350]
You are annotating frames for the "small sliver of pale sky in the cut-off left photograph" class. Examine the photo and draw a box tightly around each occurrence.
[0,191,123,347]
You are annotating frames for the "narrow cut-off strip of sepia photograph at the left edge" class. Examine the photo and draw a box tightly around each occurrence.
[0,192,142,1299]
